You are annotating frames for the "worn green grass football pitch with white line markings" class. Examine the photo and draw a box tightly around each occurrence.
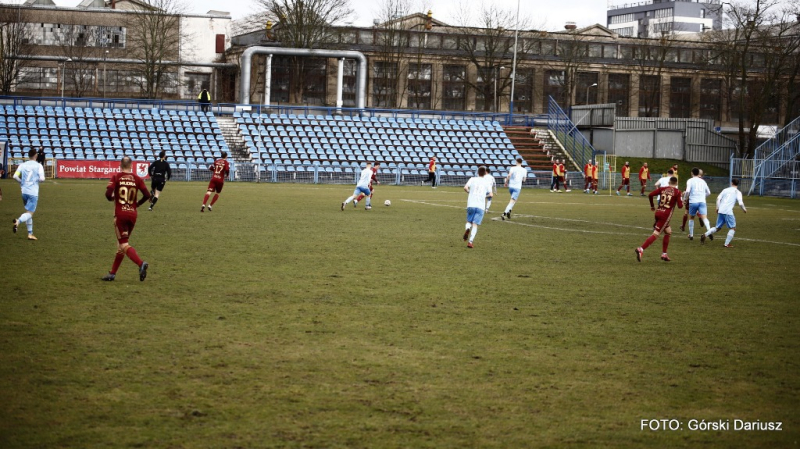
[0,180,800,448]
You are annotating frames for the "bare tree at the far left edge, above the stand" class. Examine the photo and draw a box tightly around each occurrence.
[0,7,33,95]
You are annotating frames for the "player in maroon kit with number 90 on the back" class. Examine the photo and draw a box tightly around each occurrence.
[101,156,150,281]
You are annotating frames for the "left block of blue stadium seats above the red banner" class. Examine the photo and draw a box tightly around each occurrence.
[0,105,228,169]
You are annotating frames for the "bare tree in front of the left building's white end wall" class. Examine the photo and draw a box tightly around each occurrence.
[126,0,187,98]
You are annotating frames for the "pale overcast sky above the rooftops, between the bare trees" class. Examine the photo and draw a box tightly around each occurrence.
[29,0,608,31]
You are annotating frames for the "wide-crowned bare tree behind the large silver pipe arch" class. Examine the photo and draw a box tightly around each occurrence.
[256,0,352,103]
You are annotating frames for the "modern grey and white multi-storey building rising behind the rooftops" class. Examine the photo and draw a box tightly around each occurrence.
[606,0,722,38]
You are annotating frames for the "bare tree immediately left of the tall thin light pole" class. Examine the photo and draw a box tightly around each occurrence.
[454,4,530,111]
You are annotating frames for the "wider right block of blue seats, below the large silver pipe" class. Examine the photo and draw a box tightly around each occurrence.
[234,112,527,176]
